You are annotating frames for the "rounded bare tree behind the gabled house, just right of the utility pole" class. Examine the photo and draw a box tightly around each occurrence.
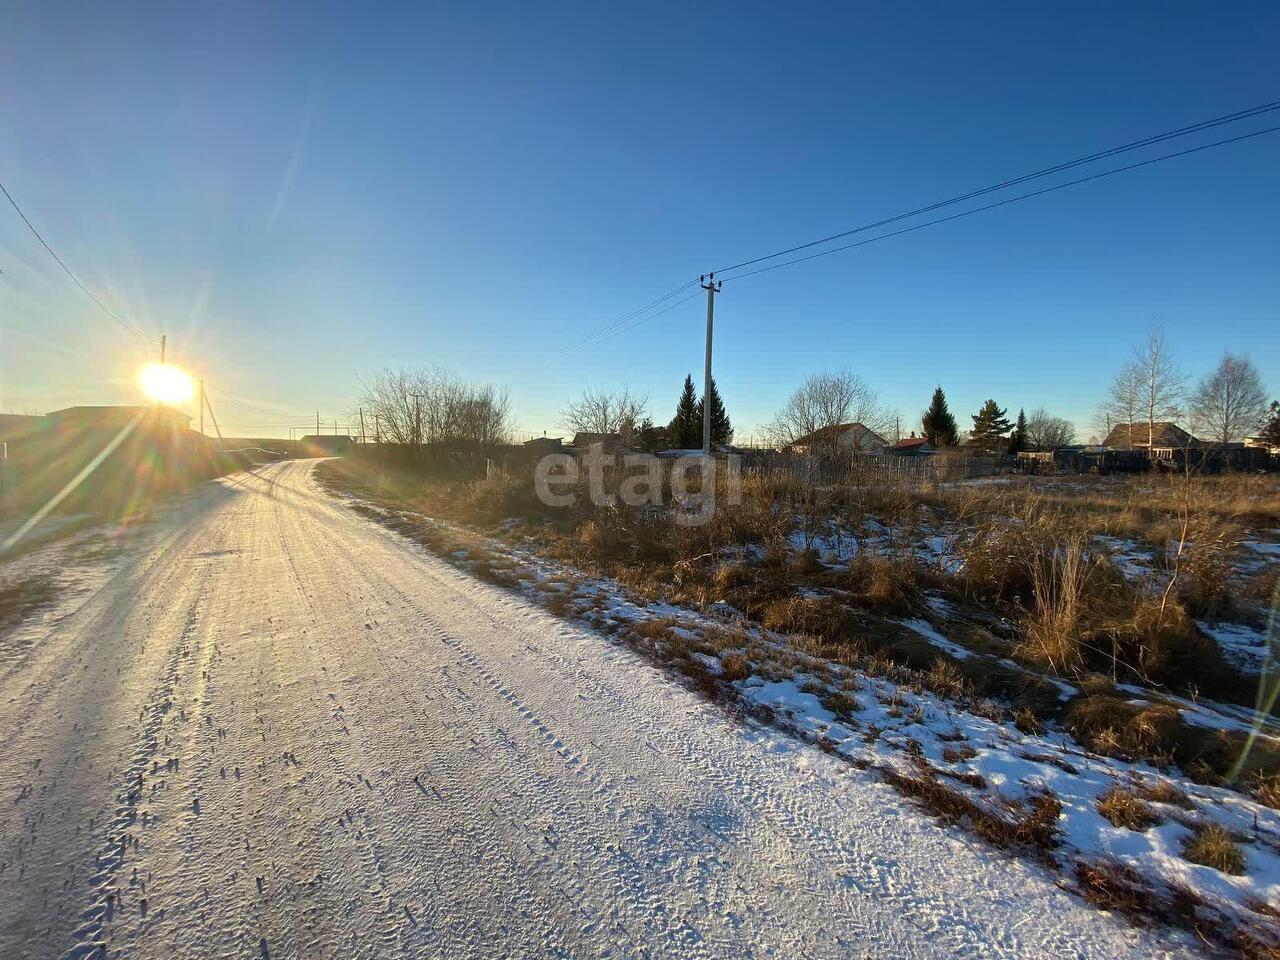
[768,370,893,456]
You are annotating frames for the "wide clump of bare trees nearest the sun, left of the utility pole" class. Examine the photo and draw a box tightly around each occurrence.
[360,367,511,448]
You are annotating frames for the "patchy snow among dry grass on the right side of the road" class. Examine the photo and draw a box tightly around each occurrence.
[337,473,1280,957]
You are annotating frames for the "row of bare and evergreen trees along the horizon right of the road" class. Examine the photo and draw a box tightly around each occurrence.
[360,330,1280,454]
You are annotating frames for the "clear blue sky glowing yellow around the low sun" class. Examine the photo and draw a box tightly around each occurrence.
[0,3,1280,435]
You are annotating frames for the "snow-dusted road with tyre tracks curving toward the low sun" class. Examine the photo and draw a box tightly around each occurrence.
[0,461,1177,959]
